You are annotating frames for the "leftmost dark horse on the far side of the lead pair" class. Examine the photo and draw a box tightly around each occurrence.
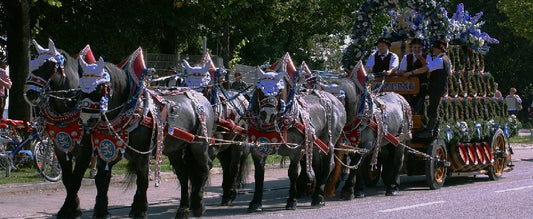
[24,40,92,218]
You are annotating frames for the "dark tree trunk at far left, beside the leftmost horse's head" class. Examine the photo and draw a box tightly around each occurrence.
[6,0,30,121]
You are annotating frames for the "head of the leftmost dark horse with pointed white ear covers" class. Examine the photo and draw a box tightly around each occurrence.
[24,39,69,106]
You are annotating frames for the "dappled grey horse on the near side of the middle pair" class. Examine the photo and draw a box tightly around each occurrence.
[247,68,346,212]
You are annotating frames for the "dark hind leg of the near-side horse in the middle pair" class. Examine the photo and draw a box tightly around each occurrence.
[311,149,334,207]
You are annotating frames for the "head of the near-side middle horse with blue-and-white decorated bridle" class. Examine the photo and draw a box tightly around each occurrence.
[256,68,287,127]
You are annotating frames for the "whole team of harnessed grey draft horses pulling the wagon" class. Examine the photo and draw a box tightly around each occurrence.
[24,40,412,218]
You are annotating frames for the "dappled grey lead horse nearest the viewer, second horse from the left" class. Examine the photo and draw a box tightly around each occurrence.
[80,48,215,218]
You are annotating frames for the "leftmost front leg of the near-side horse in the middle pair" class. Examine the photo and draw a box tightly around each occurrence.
[248,154,267,213]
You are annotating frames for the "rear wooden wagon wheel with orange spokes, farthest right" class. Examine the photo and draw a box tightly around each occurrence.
[487,129,507,180]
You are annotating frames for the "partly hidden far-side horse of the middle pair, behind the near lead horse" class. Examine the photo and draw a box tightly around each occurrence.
[183,61,250,206]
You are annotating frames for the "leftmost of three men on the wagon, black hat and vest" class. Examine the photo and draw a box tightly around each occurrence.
[366,37,399,75]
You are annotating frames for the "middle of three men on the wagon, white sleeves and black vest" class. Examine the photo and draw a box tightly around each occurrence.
[399,38,432,114]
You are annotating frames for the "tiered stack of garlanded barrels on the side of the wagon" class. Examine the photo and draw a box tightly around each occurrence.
[430,45,507,172]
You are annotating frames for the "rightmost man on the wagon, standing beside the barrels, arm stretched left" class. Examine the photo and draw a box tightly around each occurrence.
[405,40,452,138]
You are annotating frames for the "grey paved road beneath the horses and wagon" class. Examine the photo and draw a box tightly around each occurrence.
[0,145,533,218]
